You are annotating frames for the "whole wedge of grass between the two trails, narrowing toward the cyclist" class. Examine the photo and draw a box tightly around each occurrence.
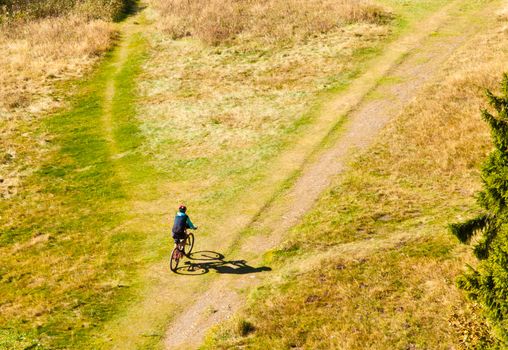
[140,1,443,226]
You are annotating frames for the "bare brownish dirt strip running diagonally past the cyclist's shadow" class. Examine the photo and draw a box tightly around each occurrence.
[165,1,498,349]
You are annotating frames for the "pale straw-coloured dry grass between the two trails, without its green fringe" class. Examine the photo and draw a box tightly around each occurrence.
[141,24,389,174]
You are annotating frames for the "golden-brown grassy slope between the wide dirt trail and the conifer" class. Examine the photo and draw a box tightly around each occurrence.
[204,1,508,349]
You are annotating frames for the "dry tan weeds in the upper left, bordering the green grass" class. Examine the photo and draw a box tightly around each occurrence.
[0,14,114,197]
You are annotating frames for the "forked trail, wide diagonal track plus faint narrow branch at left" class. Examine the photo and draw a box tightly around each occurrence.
[92,1,504,349]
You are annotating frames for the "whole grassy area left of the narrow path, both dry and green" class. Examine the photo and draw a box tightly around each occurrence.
[0,1,139,349]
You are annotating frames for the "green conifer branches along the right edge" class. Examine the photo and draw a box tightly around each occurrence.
[450,74,508,345]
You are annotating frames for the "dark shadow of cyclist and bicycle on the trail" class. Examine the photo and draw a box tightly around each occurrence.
[175,250,272,275]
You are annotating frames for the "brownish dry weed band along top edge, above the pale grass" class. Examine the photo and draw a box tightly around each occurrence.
[152,0,389,45]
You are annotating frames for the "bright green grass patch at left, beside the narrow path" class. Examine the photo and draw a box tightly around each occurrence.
[0,28,154,349]
